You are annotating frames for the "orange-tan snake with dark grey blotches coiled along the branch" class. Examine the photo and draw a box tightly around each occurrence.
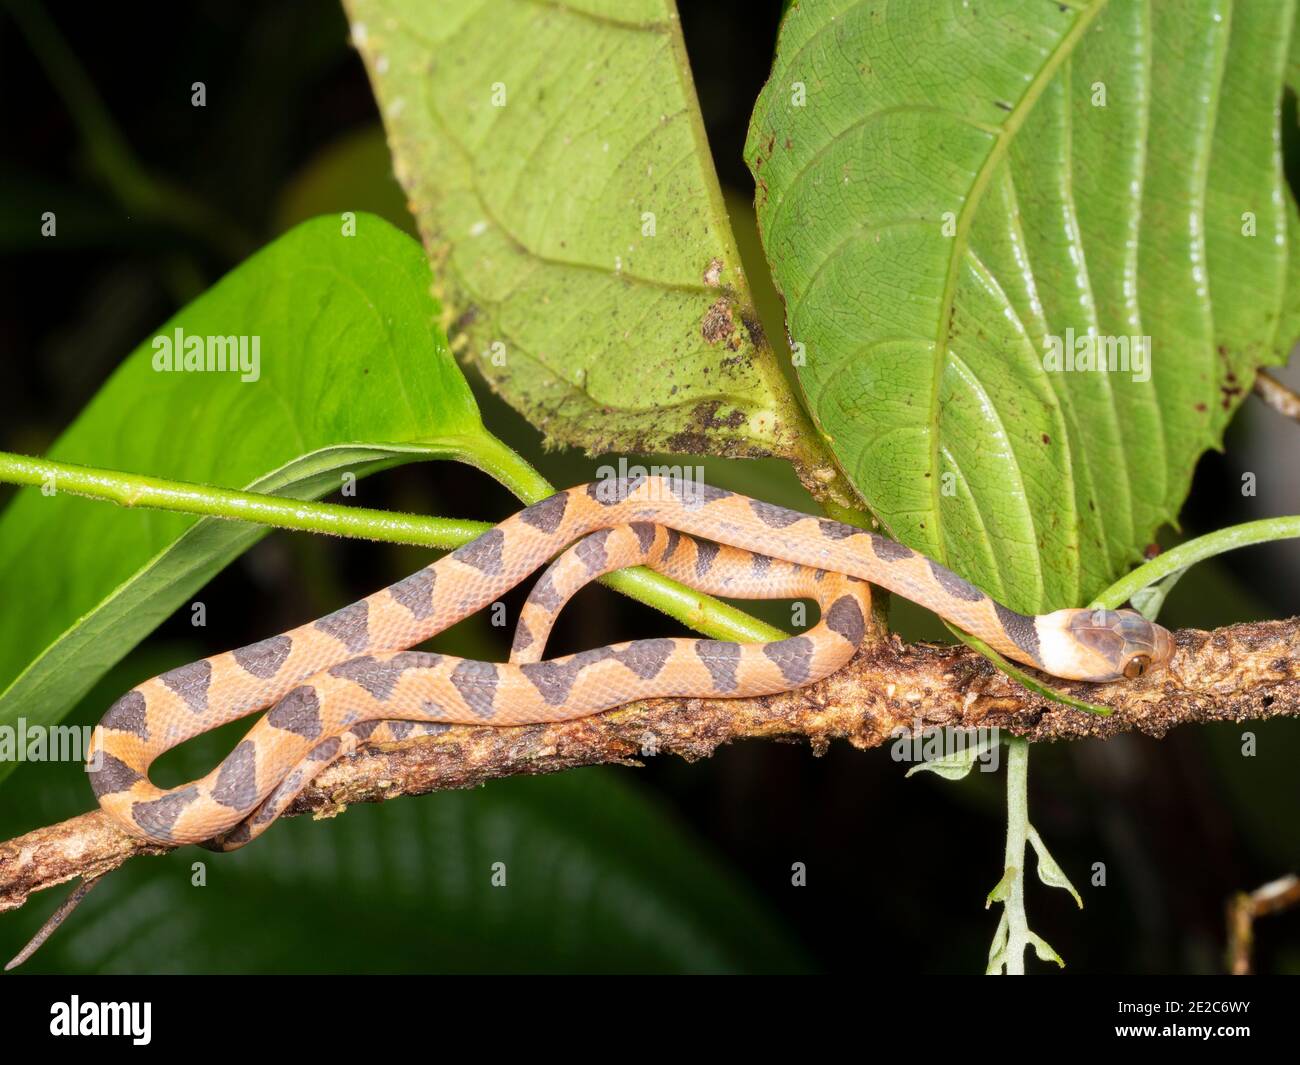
[87,473,1174,850]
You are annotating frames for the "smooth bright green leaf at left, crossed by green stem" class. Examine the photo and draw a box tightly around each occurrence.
[0,215,501,776]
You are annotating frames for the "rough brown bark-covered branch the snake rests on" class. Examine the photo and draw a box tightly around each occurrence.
[0,618,1300,912]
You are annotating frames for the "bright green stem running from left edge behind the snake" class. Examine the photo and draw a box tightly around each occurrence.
[0,438,789,644]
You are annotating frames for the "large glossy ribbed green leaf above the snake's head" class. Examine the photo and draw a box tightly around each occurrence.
[746,0,1296,610]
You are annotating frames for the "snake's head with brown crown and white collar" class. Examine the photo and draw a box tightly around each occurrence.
[1039,610,1174,681]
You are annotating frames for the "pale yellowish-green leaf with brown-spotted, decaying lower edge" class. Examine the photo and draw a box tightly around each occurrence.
[346,0,835,480]
